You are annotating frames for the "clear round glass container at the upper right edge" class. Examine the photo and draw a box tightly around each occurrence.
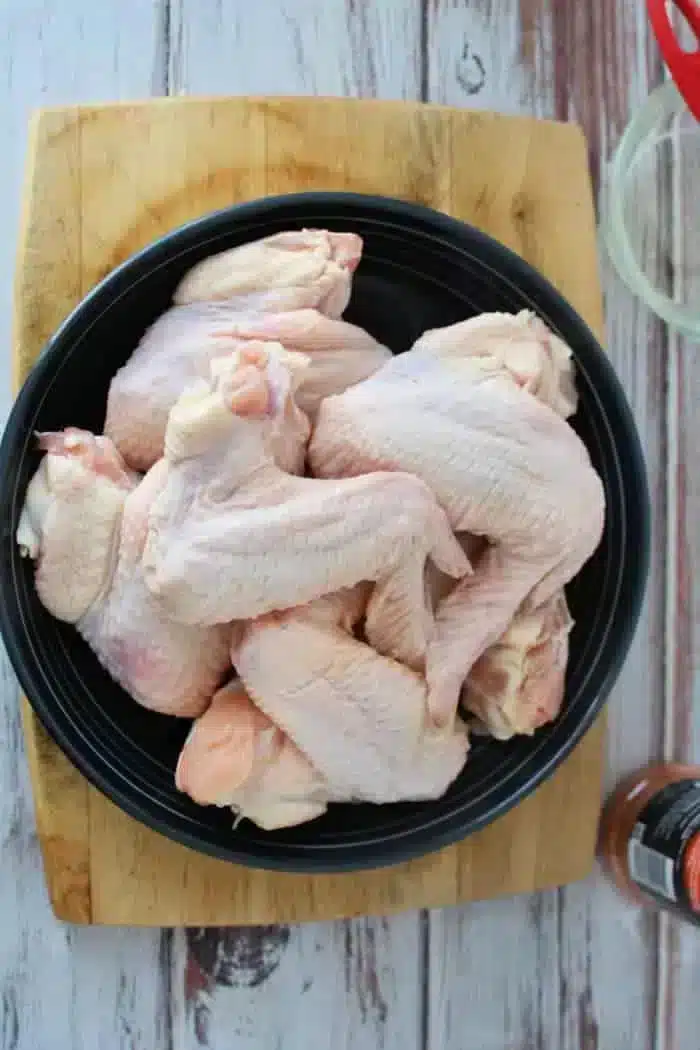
[600,81,700,340]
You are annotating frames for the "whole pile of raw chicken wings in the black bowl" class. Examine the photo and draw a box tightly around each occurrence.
[17,230,604,828]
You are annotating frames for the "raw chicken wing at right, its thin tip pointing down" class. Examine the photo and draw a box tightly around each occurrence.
[310,306,604,725]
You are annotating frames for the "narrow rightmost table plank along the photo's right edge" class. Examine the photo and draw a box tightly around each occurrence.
[658,100,700,1050]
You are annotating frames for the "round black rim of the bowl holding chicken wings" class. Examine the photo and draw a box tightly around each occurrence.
[0,191,651,874]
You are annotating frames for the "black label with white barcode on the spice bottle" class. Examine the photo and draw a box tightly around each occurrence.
[628,780,700,925]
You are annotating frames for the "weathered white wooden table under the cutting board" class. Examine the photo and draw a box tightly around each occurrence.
[0,0,700,1050]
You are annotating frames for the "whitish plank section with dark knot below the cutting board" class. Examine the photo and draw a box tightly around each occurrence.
[173,915,423,1050]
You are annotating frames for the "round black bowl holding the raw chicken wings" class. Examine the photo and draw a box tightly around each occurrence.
[0,193,650,872]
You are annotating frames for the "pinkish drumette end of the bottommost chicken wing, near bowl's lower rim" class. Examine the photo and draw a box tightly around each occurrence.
[175,681,327,831]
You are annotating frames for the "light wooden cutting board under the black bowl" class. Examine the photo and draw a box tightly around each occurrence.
[15,99,603,926]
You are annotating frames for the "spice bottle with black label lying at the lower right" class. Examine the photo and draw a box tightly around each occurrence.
[599,763,700,925]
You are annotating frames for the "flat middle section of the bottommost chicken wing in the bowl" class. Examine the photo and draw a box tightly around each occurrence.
[232,590,468,802]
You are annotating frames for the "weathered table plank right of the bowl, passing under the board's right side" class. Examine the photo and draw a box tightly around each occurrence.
[427,0,671,1050]
